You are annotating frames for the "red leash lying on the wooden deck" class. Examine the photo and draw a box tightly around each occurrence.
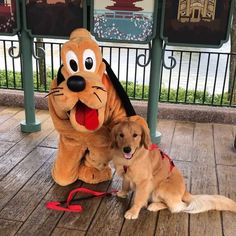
[46,188,117,212]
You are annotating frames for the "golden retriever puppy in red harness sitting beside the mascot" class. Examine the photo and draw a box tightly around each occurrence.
[111,116,236,219]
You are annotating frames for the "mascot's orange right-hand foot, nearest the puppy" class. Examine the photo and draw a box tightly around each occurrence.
[78,165,112,184]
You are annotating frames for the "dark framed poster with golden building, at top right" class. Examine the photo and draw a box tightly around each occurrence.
[161,0,233,47]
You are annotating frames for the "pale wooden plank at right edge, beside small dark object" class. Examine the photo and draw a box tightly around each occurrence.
[214,124,236,165]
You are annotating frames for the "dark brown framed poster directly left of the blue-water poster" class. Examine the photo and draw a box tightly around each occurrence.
[24,0,84,38]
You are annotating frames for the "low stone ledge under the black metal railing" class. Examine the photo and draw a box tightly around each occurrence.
[0,89,236,124]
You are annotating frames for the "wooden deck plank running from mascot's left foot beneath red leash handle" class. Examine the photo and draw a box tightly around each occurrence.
[18,181,81,236]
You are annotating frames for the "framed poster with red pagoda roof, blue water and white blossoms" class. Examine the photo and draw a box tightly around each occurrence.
[90,0,158,43]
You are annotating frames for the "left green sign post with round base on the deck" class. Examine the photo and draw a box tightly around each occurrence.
[20,1,41,133]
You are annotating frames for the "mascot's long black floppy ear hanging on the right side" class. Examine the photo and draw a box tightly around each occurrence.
[103,58,136,116]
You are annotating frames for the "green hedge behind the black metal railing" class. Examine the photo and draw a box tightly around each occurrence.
[0,69,232,105]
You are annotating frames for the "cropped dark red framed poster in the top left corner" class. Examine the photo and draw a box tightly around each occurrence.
[0,0,20,36]
